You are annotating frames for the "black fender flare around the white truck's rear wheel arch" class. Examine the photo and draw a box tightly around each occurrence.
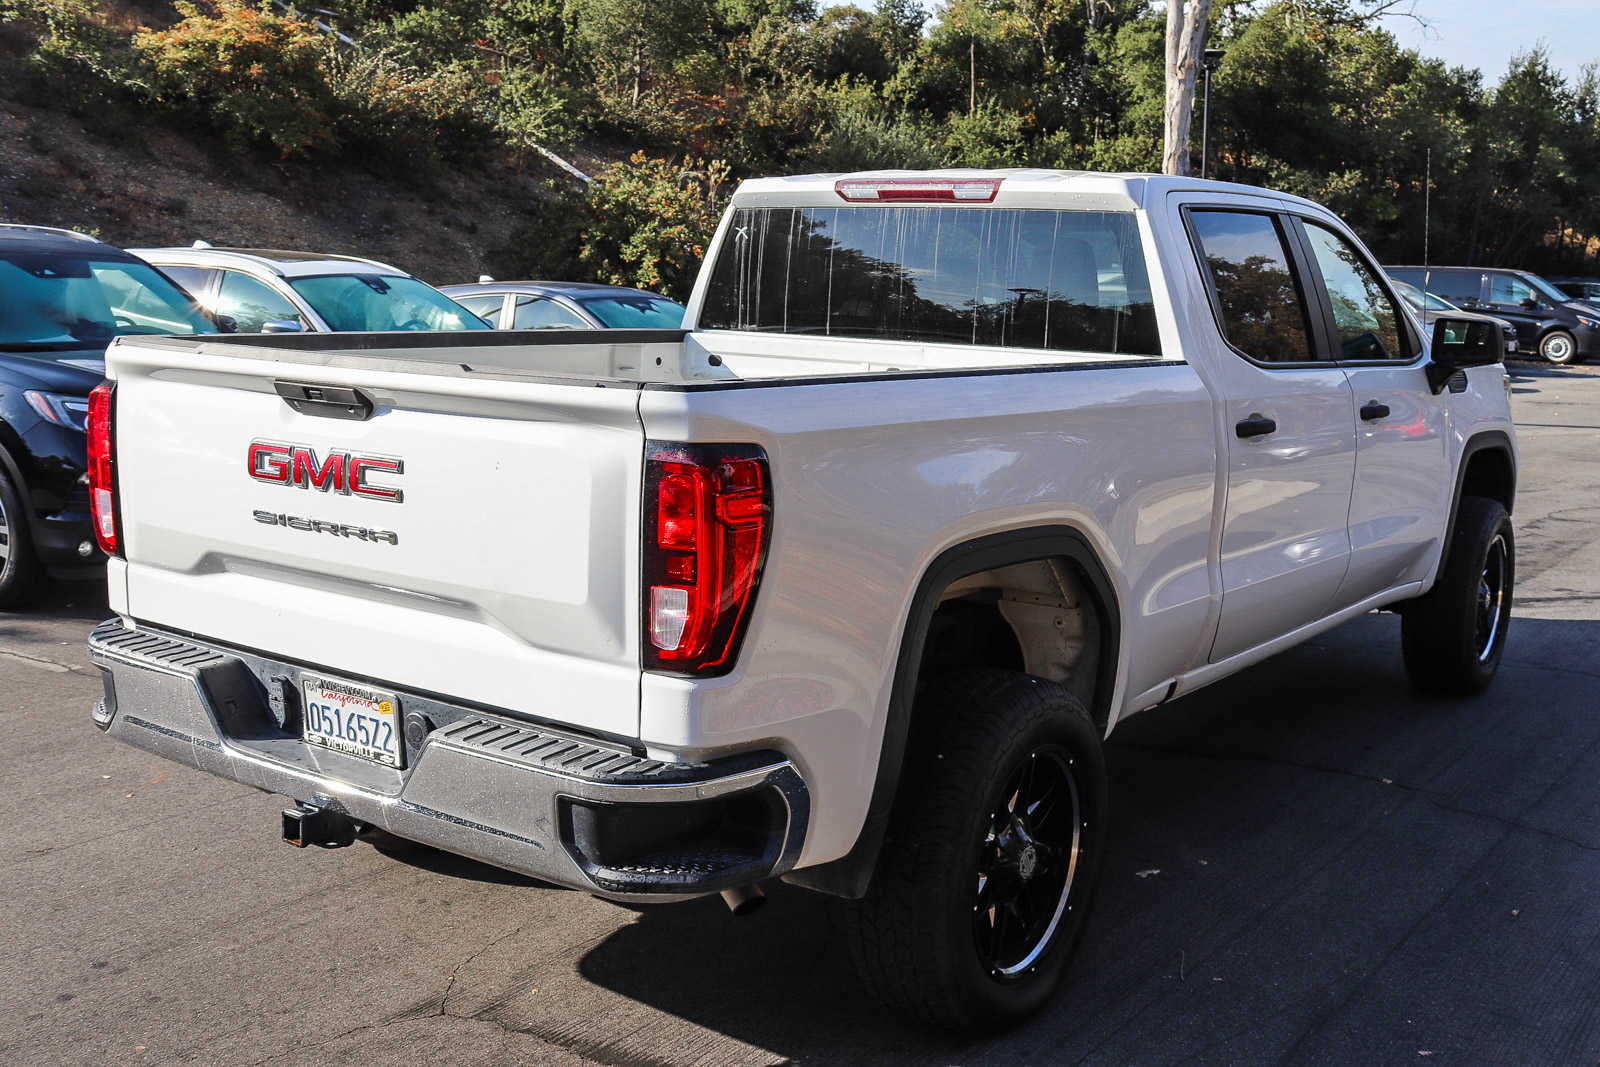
[784,526,1122,897]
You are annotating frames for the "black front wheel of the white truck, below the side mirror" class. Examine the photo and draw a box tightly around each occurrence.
[1400,496,1517,696]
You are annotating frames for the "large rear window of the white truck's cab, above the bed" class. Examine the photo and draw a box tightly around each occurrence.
[699,206,1162,355]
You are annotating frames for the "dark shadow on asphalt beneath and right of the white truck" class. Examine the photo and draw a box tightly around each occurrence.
[560,614,1600,1062]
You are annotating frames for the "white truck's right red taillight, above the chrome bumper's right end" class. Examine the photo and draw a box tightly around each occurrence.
[643,443,773,675]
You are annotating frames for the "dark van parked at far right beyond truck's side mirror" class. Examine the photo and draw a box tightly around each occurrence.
[1384,267,1600,363]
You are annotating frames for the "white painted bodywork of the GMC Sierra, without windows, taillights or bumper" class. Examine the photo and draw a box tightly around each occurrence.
[93,171,1512,895]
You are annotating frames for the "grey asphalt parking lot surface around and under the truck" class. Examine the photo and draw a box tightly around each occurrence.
[0,365,1600,1065]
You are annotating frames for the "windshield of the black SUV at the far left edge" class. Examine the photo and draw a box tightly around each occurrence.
[0,251,218,352]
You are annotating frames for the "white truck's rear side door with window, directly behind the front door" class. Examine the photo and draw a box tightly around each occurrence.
[1182,202,1355,662]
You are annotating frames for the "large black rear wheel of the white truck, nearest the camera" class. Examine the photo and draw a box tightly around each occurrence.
[845,670,1109,1030]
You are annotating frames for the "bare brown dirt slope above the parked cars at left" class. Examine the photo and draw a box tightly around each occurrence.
[0,87,569,285]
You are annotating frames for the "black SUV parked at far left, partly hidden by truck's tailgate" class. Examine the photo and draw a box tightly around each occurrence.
[0,222,218,609]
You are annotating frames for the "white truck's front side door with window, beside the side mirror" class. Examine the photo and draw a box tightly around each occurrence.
[1293,218,1454,608]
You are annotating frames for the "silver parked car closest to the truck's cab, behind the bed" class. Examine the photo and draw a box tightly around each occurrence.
[440,277,683,330]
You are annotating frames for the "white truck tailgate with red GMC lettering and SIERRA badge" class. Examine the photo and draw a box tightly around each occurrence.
[109,342,643,736]
